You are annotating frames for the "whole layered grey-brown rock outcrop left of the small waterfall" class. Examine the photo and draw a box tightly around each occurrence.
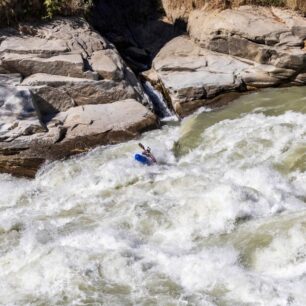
[0,19,157,177]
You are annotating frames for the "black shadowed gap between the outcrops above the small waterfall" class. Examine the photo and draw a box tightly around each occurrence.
[92,0,186,72]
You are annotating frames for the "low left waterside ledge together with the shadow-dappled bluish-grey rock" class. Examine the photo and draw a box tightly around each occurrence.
[0,76,157,177]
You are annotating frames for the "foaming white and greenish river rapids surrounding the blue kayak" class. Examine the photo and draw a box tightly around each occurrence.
[0,87,306,306]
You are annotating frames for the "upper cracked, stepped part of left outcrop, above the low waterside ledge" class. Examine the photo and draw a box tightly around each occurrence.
[0,18,149,111]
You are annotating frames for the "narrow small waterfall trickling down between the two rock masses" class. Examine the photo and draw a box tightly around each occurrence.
[143,81,176,119]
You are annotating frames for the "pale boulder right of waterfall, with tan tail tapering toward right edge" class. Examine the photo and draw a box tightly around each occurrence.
[145,36,302,116]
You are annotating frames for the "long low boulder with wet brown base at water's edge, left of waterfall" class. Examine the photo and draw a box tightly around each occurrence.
[0,95,157,177]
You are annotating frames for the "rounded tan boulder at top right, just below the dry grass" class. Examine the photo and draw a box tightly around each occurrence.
[188,6,306,70]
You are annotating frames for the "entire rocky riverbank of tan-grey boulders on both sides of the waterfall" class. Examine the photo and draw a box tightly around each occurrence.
[0,2,306,177]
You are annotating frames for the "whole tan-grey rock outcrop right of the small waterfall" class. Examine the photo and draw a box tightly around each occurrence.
[144,6,306,116]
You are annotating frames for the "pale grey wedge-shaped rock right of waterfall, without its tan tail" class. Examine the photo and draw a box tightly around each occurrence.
[151,36,249,115]
